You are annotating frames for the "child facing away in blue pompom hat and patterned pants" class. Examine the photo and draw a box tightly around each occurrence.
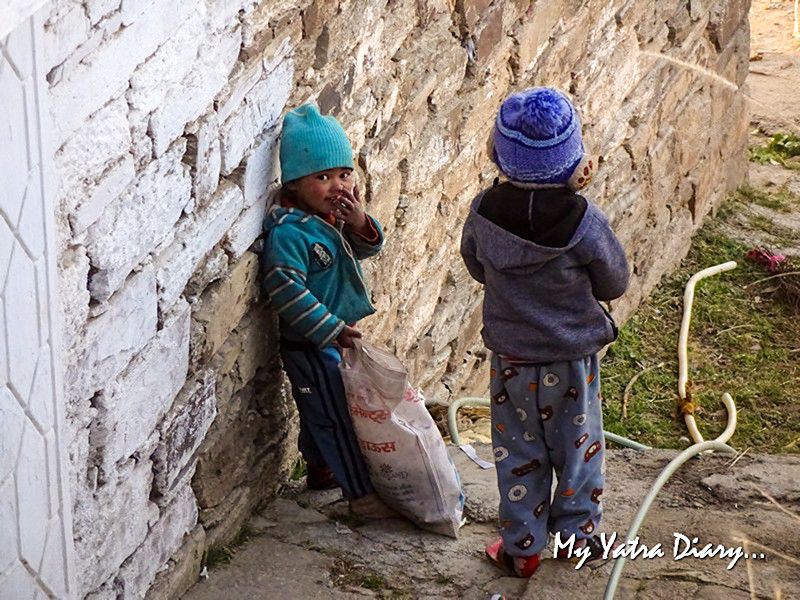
[461,88,628,577]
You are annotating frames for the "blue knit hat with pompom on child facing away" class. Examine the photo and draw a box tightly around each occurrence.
[492,87,593,188]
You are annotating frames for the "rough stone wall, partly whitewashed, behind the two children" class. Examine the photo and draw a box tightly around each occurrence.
[45,0,749,598]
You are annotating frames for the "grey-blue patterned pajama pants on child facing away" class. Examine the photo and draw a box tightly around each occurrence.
[491,354,605,556]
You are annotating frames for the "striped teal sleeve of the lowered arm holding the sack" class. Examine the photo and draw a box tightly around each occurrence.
[263,229,345,348]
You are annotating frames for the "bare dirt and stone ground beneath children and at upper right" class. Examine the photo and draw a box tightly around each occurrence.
[184,5,800,600]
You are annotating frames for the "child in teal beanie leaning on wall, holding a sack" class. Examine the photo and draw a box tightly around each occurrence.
[262,104,396,518]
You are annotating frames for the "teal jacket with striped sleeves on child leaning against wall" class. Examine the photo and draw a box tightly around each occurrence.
[262,206,383,348]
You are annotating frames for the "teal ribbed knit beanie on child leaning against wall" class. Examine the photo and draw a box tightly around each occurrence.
[280,104,354,183]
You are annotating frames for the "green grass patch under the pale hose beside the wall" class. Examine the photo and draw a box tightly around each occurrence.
[603,195,800,453]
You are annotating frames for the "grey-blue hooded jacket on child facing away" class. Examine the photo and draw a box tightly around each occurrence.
[461,184,628,363]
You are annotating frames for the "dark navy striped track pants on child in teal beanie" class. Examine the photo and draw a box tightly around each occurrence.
[281,344,373,498]
